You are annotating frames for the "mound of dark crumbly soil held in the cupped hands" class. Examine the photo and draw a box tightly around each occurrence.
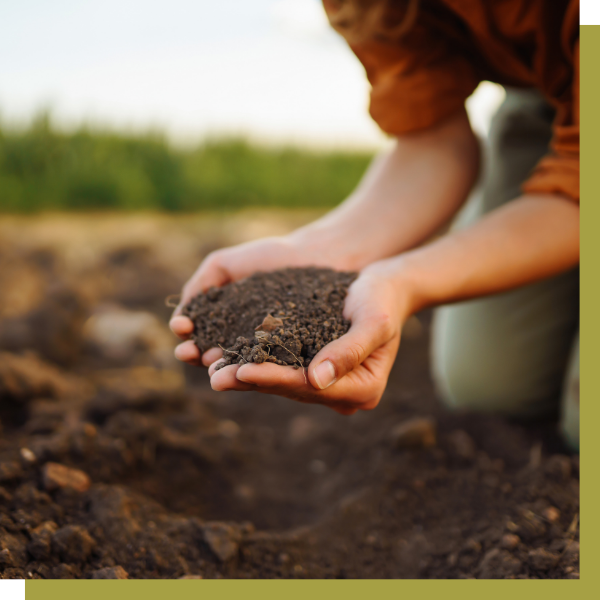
[182,267,357,368]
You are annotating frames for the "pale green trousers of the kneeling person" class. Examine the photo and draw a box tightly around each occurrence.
[431,89,579,450]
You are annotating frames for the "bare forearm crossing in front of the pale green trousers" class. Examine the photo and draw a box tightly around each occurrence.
[382,195,579,314]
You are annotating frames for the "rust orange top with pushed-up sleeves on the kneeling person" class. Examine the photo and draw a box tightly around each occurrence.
[324,0,580,202]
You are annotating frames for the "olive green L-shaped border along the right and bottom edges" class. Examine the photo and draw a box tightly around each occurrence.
[25,24,600,600]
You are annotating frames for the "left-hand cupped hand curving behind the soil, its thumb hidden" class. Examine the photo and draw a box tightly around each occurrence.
[169,236,318,367]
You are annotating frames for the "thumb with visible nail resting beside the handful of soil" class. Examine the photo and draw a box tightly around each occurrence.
[308,313,394,390]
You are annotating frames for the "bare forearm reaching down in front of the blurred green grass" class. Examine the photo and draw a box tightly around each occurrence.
[291,112,479,269]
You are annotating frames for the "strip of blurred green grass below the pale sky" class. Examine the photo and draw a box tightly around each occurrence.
[0,113,372,213]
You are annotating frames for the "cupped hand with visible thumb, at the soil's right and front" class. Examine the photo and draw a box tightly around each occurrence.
[208,261,410,415]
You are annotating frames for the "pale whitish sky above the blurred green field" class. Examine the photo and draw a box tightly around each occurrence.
[0,0,503,147]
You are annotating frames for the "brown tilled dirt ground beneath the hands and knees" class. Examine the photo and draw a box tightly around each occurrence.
[0,212,579,580]
